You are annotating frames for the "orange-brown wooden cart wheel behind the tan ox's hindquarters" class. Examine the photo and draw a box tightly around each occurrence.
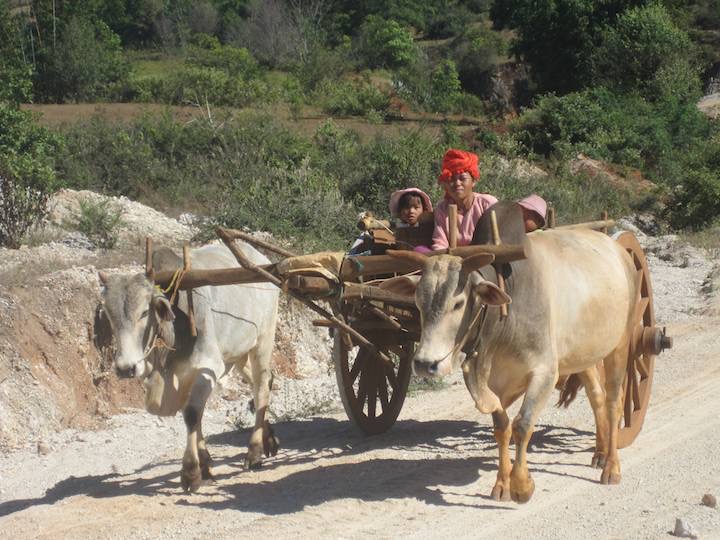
[614,232,655,448]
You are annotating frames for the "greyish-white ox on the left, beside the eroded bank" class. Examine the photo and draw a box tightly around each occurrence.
[99,242,278,491]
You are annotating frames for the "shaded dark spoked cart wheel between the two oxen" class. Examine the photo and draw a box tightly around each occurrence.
[333,331,414,435]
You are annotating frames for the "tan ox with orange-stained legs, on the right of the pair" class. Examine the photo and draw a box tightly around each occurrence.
[394,230,636,502]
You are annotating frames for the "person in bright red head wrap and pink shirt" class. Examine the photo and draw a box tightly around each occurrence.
[432,149,497,250]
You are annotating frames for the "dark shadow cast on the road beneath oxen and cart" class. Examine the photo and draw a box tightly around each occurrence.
[0,418,594,516]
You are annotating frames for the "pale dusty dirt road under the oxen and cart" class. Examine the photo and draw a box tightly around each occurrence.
[0,234,720,540]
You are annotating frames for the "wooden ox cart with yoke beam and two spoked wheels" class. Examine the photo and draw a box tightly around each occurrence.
[146,209,672,448]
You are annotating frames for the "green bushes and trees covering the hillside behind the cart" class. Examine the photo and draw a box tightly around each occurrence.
[0,0,720,249]
